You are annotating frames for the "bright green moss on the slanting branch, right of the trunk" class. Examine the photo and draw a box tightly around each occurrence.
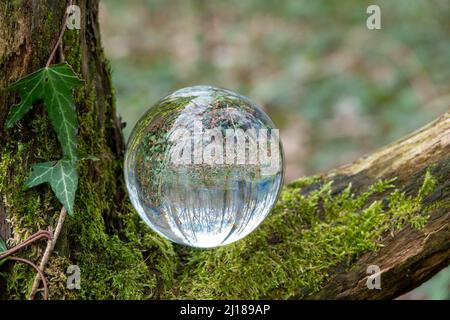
[165,173,436,299]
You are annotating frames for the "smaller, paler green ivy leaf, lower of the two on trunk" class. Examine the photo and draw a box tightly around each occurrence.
[25,159,78,215]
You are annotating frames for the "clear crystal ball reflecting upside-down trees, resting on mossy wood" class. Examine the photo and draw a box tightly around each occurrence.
[125,86,284,248]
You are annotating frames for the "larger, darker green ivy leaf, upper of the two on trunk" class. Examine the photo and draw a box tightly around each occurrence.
[5,63,83,160]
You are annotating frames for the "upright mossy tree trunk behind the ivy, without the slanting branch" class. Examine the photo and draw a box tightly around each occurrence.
[0,0,162,298]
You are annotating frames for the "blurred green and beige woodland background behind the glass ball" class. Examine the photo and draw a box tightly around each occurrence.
[100,0,450,299]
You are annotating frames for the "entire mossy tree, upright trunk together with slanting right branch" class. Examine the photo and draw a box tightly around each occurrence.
[0,0,450,299]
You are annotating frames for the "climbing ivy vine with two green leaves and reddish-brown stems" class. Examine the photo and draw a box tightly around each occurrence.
[0,0,81,299]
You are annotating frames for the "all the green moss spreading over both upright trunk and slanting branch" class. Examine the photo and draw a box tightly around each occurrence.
[0,2,442,299]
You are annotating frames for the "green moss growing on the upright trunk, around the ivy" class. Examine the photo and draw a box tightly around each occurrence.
[0,23,178,299]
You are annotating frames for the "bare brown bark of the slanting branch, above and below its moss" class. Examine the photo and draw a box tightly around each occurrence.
[310,113,450,299]
